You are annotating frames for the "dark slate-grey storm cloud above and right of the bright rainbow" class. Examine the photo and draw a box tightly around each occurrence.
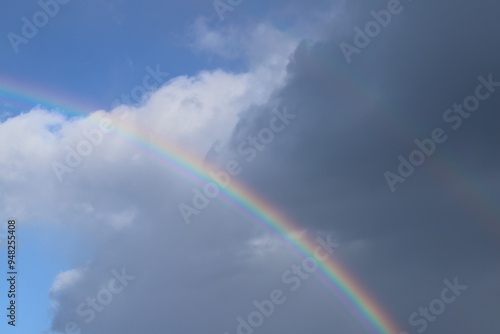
[217,1,500,333]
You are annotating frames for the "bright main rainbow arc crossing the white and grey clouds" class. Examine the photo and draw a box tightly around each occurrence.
[0,81,399,334]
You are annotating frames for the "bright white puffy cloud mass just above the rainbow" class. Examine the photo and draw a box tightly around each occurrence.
[142,70,258,155]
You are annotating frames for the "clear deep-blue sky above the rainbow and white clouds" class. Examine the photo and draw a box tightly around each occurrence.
[0,1,258,108]
